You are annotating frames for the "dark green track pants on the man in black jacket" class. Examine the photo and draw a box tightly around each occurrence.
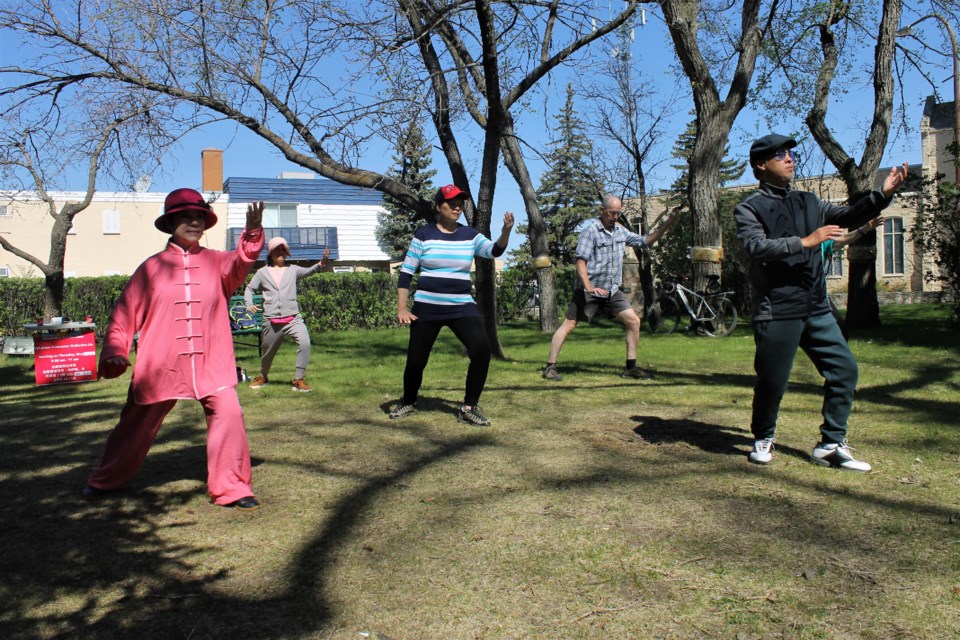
[750,313,858,443]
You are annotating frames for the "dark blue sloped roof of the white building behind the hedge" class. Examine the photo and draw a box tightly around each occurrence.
[223,177,383,205]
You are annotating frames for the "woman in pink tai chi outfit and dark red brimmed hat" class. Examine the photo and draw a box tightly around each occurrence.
[83,189,263,511]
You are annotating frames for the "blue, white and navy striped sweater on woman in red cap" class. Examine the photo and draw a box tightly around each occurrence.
[397,224,503,320]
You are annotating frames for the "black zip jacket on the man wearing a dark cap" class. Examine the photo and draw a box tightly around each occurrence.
[733,182,891,322]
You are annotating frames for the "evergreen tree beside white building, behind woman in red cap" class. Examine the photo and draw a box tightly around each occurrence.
[376,120,437,259]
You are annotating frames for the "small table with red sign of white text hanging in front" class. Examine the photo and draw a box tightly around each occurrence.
[23,322,97,385]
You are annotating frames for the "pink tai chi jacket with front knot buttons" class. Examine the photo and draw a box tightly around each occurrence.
[100,229,263,404]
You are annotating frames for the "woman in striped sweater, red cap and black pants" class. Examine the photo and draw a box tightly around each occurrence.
[390,184,513,427]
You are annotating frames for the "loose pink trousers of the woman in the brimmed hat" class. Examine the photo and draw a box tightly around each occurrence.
[87,387,253,505]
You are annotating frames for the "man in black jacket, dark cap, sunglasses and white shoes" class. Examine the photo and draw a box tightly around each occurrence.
[734,133,907,473]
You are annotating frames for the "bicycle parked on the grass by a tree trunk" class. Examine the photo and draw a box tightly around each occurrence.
[654,276,737,338]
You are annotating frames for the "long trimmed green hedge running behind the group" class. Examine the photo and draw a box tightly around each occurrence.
[0,269,574,337]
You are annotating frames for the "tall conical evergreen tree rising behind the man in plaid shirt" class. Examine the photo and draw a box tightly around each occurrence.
[511,85,601,269]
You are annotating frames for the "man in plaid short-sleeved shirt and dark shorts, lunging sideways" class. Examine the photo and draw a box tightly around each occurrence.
[543,194,679,380]
